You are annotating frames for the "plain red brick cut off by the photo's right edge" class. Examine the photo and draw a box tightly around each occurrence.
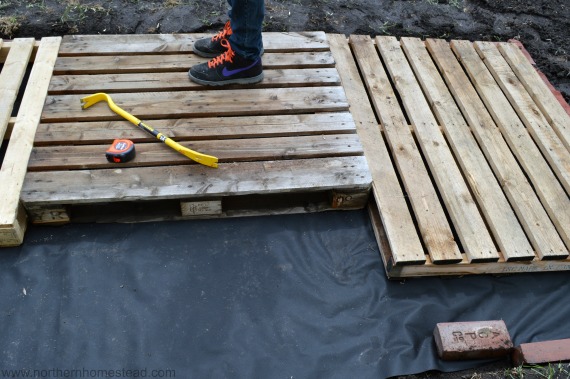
[512,338,570,366]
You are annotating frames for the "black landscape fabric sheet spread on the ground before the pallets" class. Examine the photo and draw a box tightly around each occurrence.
[0,211,570,379]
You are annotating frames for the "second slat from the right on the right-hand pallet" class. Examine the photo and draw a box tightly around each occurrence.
[474,42,570,193]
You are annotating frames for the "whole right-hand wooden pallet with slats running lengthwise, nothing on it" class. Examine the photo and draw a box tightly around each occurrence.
[329,35,570,278]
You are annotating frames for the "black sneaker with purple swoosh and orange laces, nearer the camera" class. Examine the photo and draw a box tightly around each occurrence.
[188,39,263,86]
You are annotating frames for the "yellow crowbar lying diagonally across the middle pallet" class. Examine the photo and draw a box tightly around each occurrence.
[81,92,218,168]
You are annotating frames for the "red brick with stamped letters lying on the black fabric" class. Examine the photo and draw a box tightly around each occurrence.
[433,320,513,361]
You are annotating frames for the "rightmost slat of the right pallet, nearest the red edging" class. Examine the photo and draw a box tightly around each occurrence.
[498,42,570,150]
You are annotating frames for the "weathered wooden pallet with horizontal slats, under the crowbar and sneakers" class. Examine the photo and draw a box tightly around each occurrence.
[1,32,372,243]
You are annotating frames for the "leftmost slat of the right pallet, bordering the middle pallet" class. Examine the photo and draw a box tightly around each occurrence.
[328,34,426,264]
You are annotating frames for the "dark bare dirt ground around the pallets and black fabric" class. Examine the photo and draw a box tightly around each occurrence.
[0,0,570,379]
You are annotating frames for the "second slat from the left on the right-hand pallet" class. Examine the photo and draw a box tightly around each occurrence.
[350,36,462,263]
